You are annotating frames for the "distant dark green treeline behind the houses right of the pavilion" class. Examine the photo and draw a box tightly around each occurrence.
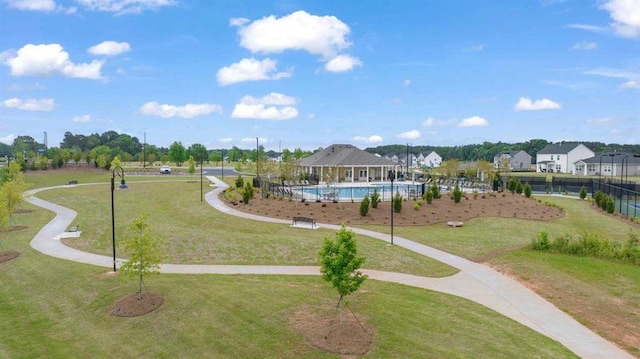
[365,139,640,162]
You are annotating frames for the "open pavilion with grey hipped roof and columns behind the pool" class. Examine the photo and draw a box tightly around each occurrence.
[300,144,398,182]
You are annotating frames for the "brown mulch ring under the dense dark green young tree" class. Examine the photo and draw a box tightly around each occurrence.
[290,306,376,356]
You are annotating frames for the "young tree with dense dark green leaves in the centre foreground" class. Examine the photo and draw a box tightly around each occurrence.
[319,225,367,319]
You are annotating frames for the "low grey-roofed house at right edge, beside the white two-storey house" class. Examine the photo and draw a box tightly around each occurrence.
[575,152,640,178]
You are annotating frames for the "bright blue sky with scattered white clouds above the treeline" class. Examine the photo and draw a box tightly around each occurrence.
[0,0,640,150]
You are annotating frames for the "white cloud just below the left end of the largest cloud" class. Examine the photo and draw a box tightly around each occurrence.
[216,58,291,86]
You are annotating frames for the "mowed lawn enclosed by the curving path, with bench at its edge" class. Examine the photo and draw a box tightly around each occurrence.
[37,181,458,277]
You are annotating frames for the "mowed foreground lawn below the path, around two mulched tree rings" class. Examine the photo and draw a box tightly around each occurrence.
[0,205,575,358]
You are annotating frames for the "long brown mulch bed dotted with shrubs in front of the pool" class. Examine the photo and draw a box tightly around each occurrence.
[221,193,564,226]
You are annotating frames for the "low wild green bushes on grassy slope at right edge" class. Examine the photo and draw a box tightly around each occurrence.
[531,231,640,265]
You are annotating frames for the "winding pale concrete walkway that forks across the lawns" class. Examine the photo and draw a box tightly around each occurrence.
[26,180,633,359]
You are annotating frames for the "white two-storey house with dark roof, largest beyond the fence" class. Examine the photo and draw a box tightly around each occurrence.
[536,142,595,174]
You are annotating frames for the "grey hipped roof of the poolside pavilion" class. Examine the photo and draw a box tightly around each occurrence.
[300,144,395,167]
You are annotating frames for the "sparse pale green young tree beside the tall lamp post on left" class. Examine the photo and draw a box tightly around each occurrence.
[120,214,165,299]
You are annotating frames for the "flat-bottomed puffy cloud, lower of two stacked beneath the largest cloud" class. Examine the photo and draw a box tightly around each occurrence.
[231,92,298,121]
